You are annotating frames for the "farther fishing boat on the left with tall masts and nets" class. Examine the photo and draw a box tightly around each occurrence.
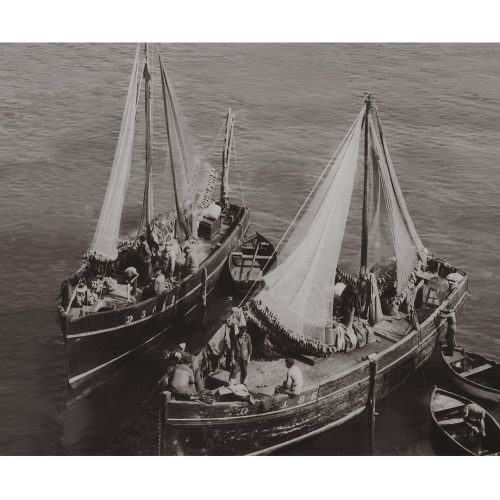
[58,45,250,386]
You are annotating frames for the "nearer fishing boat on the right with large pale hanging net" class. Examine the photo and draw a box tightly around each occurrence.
[160,95,468,455]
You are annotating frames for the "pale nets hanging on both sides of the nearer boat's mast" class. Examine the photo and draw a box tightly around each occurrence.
[248,96,427,348]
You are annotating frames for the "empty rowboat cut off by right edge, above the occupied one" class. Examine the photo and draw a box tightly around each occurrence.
[441,343,500,403]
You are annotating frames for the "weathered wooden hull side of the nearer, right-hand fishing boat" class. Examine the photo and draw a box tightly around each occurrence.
[161,268,468,455]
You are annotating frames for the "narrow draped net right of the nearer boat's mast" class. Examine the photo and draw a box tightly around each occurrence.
[368,106,426,293]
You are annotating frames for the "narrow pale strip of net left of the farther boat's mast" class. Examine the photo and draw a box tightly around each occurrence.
[87,46,142,262]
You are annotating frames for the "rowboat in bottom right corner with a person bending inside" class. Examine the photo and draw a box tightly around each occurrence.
[430,387,500,455]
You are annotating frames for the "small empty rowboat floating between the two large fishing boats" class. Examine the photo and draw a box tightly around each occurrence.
[228,233,276,293]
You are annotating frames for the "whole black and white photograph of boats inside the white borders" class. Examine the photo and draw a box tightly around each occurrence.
[0,0,500,496]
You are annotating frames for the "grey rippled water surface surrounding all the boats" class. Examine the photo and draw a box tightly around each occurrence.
[0,44,500,454]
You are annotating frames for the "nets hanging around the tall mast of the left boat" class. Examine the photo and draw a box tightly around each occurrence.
[85,44,222,262]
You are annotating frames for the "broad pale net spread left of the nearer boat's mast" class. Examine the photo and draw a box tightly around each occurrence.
[256,110,364,341]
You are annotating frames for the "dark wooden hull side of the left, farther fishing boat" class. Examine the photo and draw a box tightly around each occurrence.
[60,208,250,387]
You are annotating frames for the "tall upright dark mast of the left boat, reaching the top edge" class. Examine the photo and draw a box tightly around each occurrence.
[138,43,153,232]
